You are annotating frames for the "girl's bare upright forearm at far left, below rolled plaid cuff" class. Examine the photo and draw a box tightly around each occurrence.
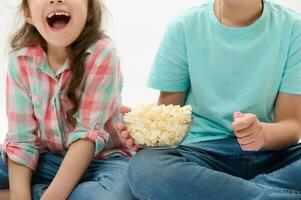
[8,159,32,200]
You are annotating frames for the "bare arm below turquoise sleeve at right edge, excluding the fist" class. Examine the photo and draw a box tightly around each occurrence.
[263,93,301,150]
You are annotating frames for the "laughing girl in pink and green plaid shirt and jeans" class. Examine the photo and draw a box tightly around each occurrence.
[0,0,131,200]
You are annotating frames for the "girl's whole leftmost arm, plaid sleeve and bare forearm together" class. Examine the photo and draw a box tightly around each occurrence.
[4,53,39,200]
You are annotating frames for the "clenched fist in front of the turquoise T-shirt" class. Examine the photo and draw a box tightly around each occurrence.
[232,112,266,151]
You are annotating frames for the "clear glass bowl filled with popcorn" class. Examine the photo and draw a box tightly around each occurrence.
[123,104,192,148]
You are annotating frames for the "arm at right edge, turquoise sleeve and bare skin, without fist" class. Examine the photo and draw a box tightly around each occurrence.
[263,20,301,150]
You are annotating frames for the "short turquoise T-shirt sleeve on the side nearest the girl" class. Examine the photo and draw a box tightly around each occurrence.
[147,20,190,92]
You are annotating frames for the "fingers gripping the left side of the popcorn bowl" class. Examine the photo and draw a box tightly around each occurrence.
[117,106,140,151]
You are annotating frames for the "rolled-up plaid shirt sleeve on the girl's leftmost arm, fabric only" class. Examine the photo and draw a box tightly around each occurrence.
[2,54,39,171]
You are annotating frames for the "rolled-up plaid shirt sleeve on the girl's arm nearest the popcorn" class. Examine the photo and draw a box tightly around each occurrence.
[67,41,122,156]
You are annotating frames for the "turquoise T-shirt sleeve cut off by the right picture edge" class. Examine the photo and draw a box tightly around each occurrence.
[279,20,301,95]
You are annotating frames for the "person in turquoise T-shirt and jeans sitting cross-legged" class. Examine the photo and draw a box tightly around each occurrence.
[120,0,301,200]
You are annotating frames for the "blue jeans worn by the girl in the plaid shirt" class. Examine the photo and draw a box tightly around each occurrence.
[0,153,133,200]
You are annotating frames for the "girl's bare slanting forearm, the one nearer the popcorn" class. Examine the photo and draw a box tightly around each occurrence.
[42,140,95,200]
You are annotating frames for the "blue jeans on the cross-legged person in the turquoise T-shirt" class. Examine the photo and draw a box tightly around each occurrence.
[128,138,301,200]
